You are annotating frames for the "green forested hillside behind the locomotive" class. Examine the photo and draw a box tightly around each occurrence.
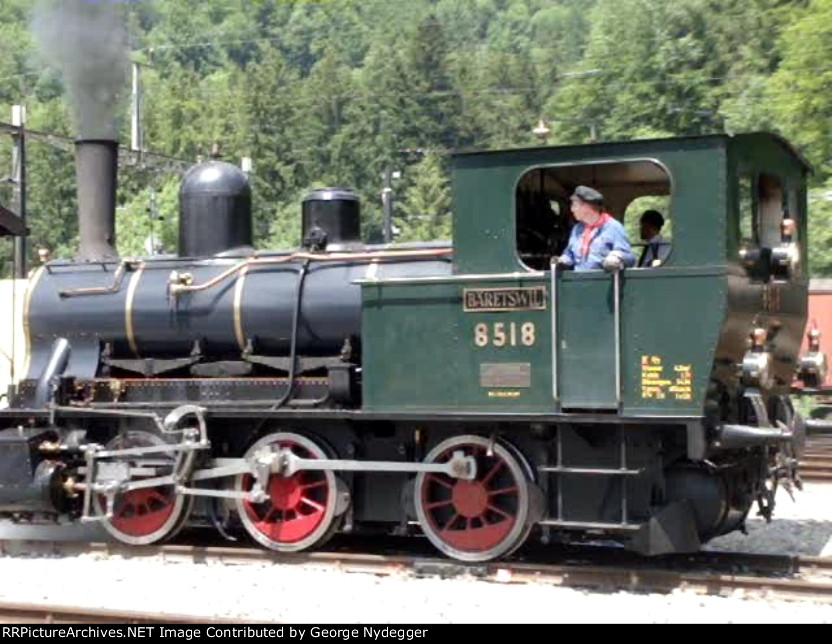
[0,0,832,275]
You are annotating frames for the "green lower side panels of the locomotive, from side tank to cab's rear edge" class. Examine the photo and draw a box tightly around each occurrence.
[363,269,725,415]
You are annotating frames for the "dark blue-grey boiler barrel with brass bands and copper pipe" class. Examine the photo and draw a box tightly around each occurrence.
[26,258,451,378]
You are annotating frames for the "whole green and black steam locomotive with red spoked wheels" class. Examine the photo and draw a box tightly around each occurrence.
[0,133,825,561]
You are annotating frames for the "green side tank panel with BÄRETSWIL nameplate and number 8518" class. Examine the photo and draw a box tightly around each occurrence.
[363,278,552,412]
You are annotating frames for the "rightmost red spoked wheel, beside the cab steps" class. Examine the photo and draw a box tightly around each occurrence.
[414,436,533,561]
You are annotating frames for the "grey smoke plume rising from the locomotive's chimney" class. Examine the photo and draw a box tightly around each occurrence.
[32,0,128,139]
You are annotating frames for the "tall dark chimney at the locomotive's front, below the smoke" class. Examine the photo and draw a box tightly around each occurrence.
[75,139,118,261]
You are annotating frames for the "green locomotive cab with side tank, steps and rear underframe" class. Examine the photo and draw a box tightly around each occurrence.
[362,133,810,555]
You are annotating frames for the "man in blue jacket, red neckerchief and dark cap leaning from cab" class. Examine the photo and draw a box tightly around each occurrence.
[557,186,636,272]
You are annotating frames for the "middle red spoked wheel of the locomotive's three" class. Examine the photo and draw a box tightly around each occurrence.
[235,432,341,552]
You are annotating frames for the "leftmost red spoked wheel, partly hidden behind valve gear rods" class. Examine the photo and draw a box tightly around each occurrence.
[95,431,193,546]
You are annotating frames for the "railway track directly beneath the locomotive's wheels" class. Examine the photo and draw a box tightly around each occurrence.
[0,542,832,612]
